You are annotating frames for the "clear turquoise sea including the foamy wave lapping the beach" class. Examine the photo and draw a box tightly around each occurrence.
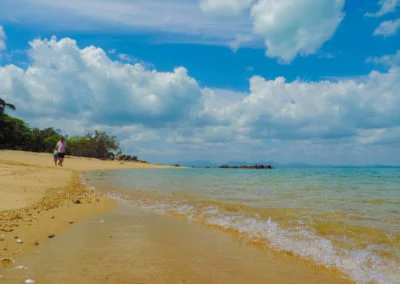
[82,168,400,283]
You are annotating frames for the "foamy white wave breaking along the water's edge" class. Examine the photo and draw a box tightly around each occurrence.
[109,193,400,283]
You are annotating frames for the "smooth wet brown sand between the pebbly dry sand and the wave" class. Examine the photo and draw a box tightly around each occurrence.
[0,206,348,284]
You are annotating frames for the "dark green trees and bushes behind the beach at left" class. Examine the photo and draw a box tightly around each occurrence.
[0,98,121,159]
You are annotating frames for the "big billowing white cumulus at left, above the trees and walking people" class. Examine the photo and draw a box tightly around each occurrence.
[0,37,203,126]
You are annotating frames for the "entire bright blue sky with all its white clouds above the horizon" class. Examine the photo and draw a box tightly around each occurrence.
[0,0,400,165]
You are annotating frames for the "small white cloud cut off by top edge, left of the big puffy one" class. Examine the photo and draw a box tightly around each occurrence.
[200,0,254,15]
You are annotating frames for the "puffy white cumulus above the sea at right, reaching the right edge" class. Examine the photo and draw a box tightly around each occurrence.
[227,67,400,140]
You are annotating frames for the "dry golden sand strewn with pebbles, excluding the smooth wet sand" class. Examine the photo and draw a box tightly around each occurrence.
[0,150,170,260]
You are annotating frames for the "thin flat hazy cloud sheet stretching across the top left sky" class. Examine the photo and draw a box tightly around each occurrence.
[0,0,251,45]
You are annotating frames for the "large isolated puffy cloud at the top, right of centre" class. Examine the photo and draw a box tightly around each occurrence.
[251,0,345,62]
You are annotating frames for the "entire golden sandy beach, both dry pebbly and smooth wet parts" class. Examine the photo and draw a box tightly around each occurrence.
[0,151,348,283]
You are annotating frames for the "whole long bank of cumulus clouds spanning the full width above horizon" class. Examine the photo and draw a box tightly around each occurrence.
[0,37,400,164]
